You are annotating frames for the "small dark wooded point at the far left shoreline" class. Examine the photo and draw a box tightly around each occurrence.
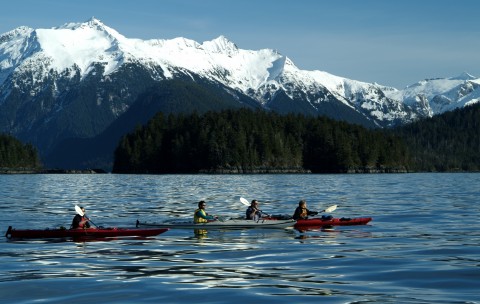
[0,134,40,171]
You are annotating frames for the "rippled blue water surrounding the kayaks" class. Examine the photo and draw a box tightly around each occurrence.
[0,174,480,304]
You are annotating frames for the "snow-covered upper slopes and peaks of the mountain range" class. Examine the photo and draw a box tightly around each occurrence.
[0,17,480,140]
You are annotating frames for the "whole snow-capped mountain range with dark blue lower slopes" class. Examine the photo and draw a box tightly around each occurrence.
[0,18,480,170]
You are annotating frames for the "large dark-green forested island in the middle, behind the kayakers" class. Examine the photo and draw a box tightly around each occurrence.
[113,109,409,173]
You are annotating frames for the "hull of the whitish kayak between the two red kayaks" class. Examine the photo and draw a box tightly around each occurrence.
[137,219,295,229]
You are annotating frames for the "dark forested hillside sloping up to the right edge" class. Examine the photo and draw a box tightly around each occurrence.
[395,104,480,172]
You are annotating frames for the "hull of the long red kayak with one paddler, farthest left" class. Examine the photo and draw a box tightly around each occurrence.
[5,226,168,239]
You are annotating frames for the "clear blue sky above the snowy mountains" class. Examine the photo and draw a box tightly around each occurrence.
[0,0,480,89]
